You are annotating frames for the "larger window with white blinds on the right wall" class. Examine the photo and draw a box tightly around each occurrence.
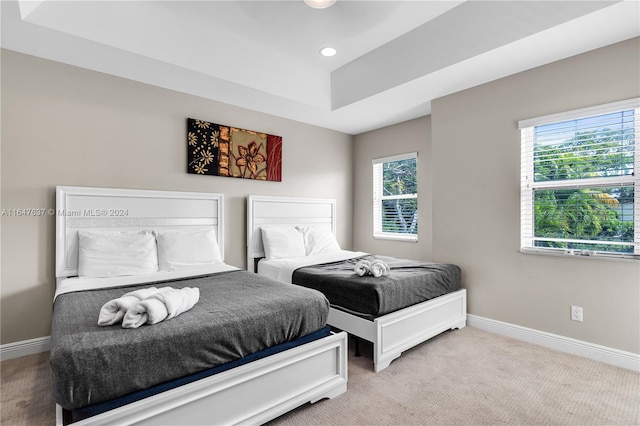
[519,98,640,260]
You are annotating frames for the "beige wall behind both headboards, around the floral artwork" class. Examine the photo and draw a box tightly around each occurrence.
[1,50,352,343]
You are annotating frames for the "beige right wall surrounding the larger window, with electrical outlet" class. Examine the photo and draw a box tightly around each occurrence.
[430,38,640,353]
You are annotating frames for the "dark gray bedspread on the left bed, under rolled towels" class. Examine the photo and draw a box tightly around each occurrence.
[50,271,329,409]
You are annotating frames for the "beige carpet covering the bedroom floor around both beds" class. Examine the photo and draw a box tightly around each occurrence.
[0,327,640,426]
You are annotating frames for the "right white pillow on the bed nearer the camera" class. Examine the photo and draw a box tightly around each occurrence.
[154,228,222,271]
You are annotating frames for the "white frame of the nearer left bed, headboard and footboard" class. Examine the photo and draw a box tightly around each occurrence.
[56,186,347,426]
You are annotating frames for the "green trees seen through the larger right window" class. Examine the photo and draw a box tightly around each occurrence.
[534,122,634,253]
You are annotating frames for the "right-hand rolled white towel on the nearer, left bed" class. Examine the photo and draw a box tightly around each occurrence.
[122,287,200,328]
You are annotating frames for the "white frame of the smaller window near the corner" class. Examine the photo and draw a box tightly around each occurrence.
[371,152,419,242]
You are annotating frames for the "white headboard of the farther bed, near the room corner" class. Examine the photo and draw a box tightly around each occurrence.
[247,195,336,272]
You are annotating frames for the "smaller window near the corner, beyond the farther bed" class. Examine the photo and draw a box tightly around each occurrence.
[372,152,418,241]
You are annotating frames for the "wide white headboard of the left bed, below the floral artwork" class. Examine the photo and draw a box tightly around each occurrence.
[55,186,224,278]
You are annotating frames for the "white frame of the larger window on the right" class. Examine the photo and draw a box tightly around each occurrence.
[518,98,640,260]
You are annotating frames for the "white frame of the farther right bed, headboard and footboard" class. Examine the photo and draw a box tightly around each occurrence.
[247,195,467,372]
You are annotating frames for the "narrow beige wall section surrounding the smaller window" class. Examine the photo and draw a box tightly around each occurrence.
[353,117,432,260]
